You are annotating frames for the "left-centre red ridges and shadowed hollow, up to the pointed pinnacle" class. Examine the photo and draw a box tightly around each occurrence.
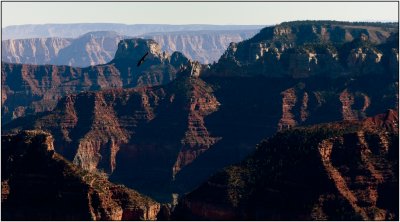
[5,62,219,201]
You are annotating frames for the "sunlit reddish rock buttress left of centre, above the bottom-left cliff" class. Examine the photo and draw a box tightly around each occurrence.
[21,88,163,173]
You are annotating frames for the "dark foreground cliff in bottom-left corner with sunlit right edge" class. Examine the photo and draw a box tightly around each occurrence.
[1,130,160,220]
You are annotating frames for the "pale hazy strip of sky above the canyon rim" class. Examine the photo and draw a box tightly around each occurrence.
[2,2,398,27]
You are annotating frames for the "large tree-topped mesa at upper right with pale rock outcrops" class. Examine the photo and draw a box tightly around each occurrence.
[213,21,398,78]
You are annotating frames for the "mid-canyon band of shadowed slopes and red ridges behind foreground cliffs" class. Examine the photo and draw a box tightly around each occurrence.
[3,63,397,201]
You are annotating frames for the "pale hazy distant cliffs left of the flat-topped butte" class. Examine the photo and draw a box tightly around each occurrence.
[1,32,127,67]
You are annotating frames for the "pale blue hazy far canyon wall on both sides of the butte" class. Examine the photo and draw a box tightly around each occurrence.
[2,29,258,67]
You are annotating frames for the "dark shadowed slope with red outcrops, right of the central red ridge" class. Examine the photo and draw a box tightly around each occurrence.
[175,72,398,190]
